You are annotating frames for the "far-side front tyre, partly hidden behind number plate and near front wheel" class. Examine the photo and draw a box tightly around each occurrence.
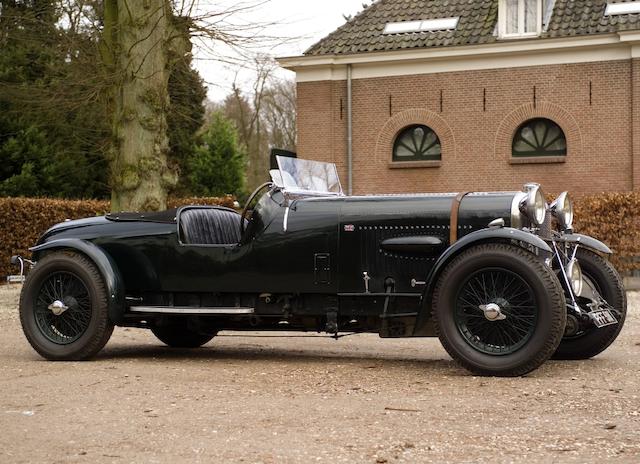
[553,249,627,359]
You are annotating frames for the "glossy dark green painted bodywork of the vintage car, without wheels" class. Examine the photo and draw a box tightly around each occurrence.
[34,187,528,332]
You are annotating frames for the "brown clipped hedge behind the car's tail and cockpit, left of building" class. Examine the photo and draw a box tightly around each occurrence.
[0,196,235,283]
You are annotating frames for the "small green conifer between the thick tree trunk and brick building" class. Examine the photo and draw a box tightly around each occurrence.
[187,111,246,196]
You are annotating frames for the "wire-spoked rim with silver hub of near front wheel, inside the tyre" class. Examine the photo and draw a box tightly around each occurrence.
[454,268,538,355]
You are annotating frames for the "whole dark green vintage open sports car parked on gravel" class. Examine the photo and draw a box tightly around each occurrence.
[12,157,626,375]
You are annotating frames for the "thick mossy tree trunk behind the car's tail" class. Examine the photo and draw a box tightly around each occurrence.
[102,0,180,211]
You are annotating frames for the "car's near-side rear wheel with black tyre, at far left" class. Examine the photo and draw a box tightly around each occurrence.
[20,251,113,361]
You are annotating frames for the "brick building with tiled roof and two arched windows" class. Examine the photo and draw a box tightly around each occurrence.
[279,0,640,195]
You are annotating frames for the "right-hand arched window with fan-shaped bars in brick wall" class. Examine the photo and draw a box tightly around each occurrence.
[511,118,567,157]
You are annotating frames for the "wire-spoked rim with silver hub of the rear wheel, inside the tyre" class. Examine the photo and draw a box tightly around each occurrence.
[34,271,92,345]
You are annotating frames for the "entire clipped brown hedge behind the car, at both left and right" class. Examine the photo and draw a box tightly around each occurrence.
[0,192,640,280]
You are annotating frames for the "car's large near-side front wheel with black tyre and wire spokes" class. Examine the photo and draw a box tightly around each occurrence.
[432,243,567,377]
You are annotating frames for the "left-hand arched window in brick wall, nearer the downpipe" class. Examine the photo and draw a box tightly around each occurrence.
[393,124,442,161]
